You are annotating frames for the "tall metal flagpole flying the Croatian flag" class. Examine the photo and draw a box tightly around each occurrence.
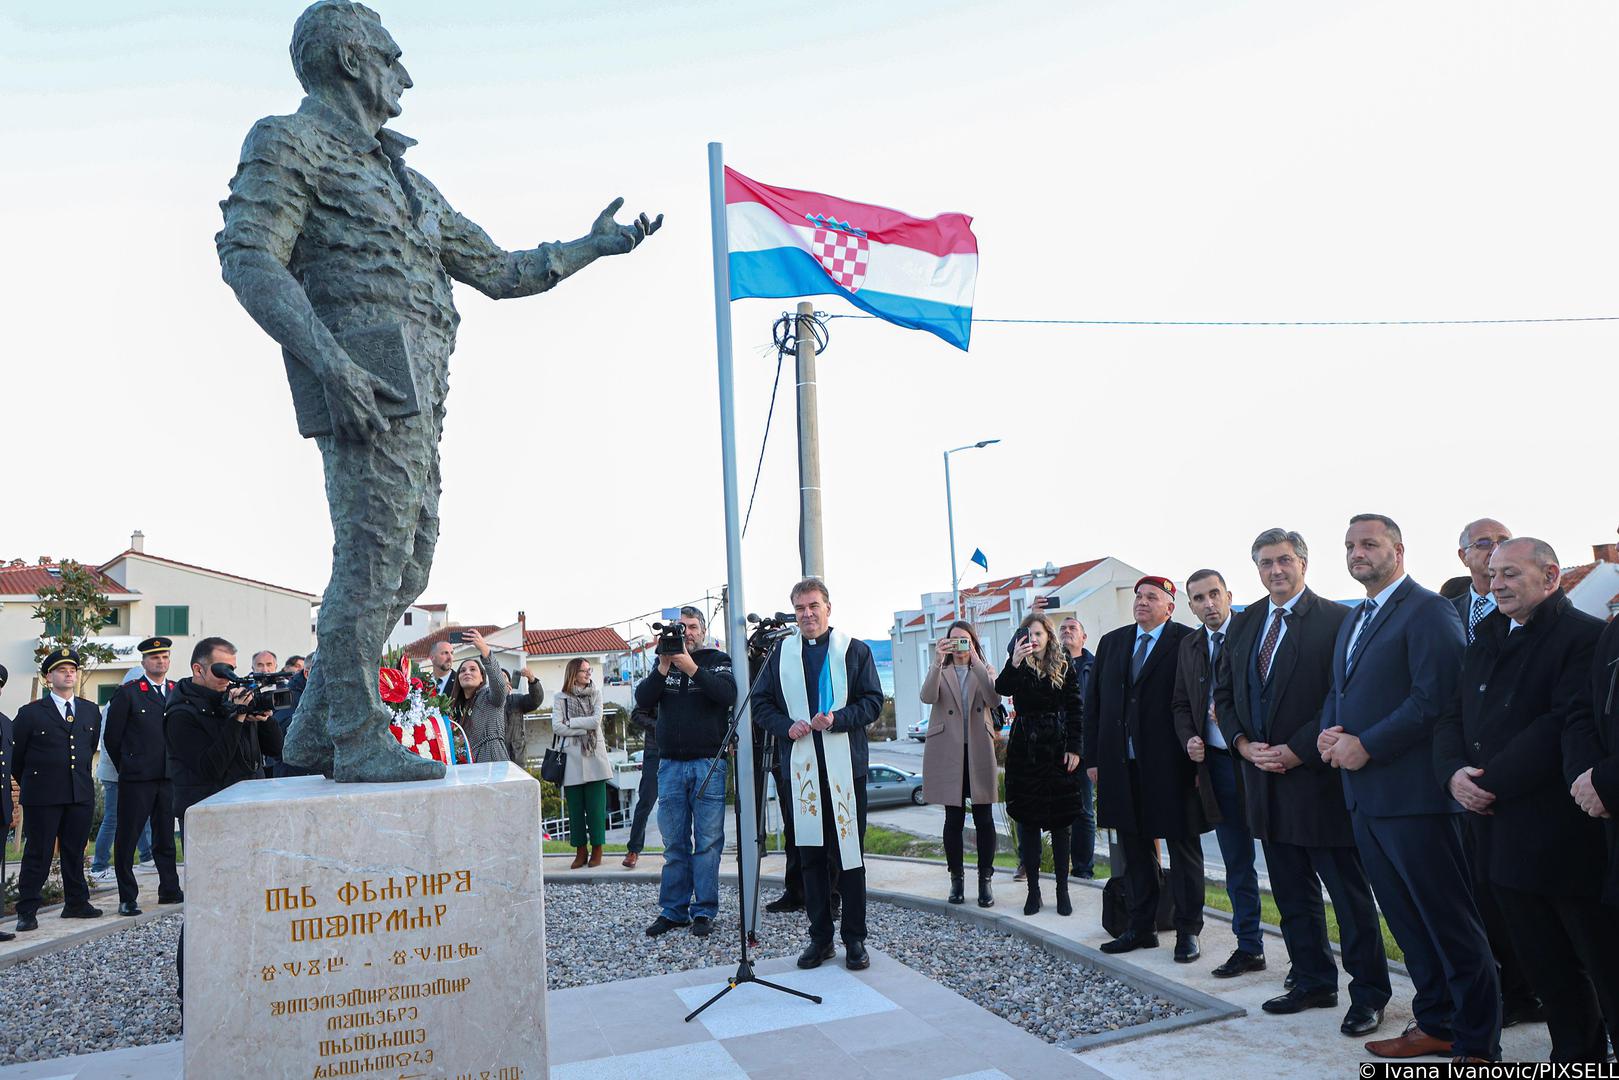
[709,142,759,933]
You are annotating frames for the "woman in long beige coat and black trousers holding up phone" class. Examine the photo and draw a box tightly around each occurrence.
[921,619,1001,907]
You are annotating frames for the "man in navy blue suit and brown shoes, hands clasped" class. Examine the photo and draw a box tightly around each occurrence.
[1318,513,1501,1061]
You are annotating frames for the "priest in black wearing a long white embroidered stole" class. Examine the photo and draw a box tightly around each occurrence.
[751,578,882,972]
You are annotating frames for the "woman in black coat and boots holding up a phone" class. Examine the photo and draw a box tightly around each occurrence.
[996,615,1085,915]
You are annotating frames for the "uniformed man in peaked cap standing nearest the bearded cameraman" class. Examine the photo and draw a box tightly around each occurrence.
[107,638,185,915]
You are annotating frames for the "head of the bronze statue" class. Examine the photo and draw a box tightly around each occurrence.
[291,0,411,126]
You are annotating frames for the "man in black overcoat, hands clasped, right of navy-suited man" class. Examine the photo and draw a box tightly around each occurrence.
[1433,538,1619,1062]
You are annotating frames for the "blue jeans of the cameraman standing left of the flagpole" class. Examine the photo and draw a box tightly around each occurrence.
[657,758,729,923]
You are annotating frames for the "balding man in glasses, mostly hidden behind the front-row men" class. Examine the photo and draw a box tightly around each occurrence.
[1441,518,1546,1028]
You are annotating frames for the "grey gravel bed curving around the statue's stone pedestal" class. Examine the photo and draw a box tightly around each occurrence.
[0,882,1183,1065]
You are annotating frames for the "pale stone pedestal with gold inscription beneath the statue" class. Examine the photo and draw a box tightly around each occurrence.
[185,763,547,1080]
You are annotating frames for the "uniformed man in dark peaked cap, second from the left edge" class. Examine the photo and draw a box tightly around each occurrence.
[11,648,100,931]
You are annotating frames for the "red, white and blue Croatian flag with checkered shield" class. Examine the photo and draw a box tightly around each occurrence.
[725,167,978,350]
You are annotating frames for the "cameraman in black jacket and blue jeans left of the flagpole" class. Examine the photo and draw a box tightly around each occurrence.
[635,607,737,938]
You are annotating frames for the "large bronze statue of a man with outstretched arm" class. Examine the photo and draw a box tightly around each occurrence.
[215,0,662,780]
